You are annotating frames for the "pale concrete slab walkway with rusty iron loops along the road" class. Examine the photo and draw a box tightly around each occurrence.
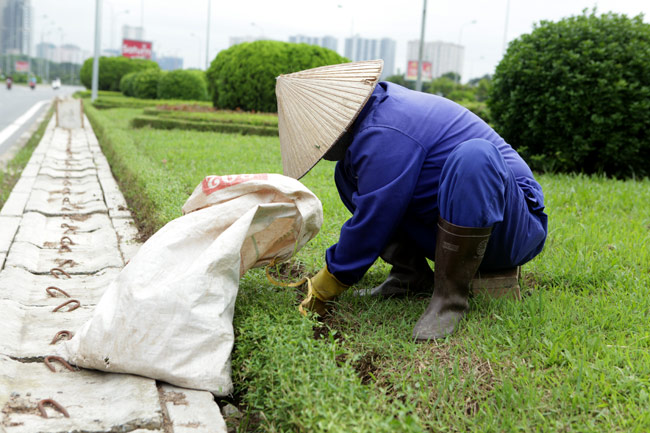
[0,103,226,433]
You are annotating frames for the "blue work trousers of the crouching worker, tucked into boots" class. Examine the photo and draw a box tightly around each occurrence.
[335,139,547,270]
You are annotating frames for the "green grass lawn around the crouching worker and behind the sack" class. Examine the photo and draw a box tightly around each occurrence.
[79,98,650,432]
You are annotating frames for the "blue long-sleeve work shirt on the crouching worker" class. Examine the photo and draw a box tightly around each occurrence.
[326,82,544,284]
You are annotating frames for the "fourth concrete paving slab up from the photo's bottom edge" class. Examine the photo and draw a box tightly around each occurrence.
[5,242,124,275]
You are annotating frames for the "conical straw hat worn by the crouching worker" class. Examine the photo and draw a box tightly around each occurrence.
[275,60,384,179]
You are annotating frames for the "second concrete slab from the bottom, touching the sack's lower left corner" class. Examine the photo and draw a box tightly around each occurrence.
[0,300,93,362]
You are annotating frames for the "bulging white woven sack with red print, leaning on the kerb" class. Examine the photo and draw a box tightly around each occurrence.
[60,174,323,396]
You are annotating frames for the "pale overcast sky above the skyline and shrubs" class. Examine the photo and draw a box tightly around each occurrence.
[32,0,650,78]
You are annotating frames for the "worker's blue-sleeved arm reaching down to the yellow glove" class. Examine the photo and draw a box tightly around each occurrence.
[326,127,426,285]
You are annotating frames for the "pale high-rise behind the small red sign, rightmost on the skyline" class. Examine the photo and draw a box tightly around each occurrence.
[406,40,465,78]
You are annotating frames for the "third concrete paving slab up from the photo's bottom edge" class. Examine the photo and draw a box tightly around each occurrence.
[0,267,121,308]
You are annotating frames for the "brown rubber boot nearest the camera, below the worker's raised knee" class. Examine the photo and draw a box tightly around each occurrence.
[413,218,492,340]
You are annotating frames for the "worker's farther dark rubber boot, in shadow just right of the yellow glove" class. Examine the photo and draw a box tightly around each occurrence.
[357,241,433,298]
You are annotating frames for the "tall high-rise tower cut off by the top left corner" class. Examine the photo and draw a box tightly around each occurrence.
[0,0,32,55]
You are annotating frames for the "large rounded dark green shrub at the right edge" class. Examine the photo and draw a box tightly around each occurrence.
[488,12,650,177]
